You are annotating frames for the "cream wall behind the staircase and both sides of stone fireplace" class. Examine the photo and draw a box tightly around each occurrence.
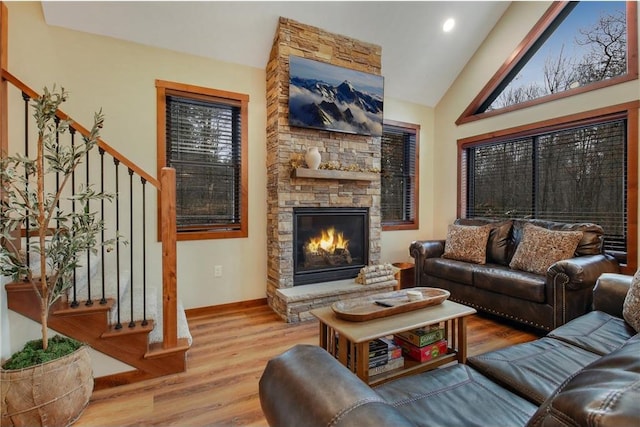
[0,2,434,364]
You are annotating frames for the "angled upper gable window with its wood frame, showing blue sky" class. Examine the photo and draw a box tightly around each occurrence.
[457,1,638,124]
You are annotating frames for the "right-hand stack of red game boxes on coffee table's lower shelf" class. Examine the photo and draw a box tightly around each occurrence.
[393,326,447,363]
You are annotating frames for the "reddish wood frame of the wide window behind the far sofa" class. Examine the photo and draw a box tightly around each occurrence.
[456,101,640,274]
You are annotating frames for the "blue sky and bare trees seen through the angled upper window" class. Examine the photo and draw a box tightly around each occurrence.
[488,2,627,112]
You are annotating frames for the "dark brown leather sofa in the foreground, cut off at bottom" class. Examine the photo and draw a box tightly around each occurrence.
[259,274,640,427]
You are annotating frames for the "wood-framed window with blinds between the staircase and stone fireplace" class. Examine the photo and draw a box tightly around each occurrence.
[157,82,248,240]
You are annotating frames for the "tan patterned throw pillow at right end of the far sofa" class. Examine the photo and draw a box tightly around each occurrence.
[509,224,582,274]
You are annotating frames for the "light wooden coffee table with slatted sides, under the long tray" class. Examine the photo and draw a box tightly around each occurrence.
[311,300,476,385]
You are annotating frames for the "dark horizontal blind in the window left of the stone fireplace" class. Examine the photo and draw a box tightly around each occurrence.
[166,96,242,229]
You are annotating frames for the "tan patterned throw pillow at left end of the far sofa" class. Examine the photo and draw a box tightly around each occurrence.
[442,224,491,264]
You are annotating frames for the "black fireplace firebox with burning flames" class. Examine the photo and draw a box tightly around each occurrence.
[293,208,369,286]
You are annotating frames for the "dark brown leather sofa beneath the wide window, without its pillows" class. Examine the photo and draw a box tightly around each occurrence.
[409,218,620,331]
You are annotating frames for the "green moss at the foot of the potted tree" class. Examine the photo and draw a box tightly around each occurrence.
[2,335,84,370]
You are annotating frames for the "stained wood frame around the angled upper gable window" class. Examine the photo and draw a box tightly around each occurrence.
[455,1,638,125]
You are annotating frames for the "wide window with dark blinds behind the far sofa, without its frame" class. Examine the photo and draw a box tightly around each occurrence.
[463,118,628,261]
